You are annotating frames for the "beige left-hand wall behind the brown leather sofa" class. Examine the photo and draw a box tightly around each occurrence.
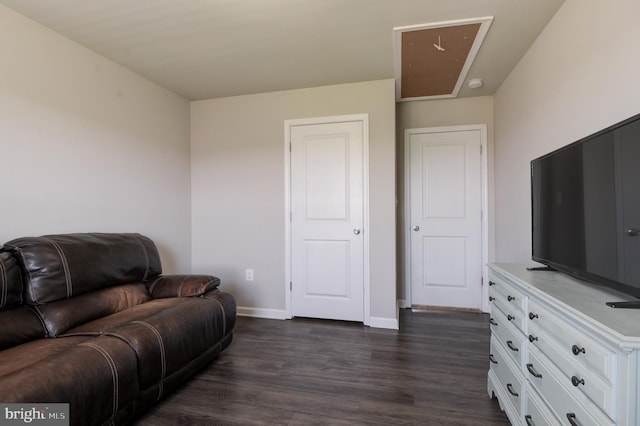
[0,6,191,272]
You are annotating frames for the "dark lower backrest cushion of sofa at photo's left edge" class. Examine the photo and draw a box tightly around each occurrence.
[0,306,47,350]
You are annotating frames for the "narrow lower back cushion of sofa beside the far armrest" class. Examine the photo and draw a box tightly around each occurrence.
[33,283,151,337]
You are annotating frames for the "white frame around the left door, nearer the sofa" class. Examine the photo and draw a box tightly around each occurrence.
[284,114,371,325]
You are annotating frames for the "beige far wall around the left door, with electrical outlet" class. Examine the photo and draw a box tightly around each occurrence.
[191,80,396,323]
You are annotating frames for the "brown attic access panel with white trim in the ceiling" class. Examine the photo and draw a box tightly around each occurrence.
[394,17,493,101]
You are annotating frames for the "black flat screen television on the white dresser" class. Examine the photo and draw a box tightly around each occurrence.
[531,114,640,308]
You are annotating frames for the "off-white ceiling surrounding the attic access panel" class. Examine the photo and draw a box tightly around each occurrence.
[0,0,564,100]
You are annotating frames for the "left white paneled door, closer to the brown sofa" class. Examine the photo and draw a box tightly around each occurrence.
[289,120,367,321]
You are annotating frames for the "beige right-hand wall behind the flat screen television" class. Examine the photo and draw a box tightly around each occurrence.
[495,0,640,262]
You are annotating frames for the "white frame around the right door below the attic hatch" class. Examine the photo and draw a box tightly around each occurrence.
[402,124,489,312]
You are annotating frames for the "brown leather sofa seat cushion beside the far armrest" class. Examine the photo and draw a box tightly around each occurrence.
[68,293,235,397]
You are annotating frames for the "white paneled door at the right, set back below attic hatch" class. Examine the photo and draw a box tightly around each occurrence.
[405,129,482,309]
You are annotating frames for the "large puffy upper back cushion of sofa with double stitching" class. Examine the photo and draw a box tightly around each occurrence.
[5,233,162,305]
